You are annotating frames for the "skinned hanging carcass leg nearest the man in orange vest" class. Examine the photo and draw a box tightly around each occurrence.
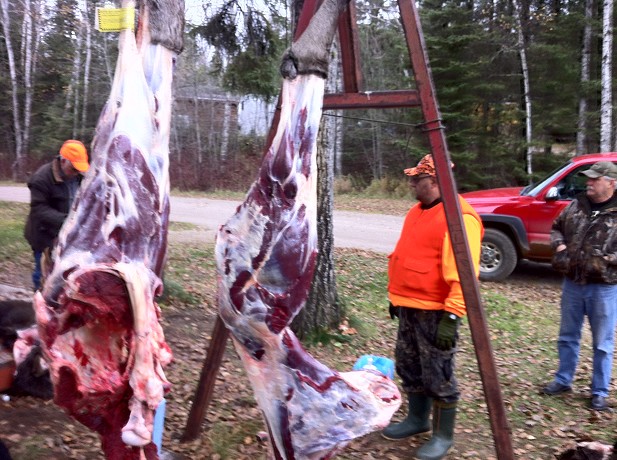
[216,0,401,460]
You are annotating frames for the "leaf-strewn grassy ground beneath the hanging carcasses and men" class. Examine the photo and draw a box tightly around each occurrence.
[0,199,616,460]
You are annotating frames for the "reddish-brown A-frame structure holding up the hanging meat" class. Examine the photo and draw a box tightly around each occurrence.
[183,0,514,460]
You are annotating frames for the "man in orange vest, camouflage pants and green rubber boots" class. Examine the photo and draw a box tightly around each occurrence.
[382,155,484,460]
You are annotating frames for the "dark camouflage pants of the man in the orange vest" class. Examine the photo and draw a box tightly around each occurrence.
[395,307,459,403]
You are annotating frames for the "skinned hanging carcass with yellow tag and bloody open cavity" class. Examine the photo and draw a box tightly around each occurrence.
[34,0,184,459]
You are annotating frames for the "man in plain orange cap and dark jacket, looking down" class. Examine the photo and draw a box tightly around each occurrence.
[24,139,90,290]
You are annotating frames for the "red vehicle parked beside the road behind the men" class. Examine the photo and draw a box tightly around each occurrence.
[463,152,617,281]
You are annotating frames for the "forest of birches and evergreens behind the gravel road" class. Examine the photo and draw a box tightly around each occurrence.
[0,0,617,196]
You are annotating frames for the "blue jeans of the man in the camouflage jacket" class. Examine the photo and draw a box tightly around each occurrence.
[555,278,617,397]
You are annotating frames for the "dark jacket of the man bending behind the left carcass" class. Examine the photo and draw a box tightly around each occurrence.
[24,158,81,251]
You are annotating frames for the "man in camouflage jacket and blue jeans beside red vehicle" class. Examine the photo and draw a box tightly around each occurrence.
[543,161,617,410]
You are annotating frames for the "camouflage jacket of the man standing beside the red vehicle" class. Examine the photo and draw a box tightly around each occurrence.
[551,193,617,284]
